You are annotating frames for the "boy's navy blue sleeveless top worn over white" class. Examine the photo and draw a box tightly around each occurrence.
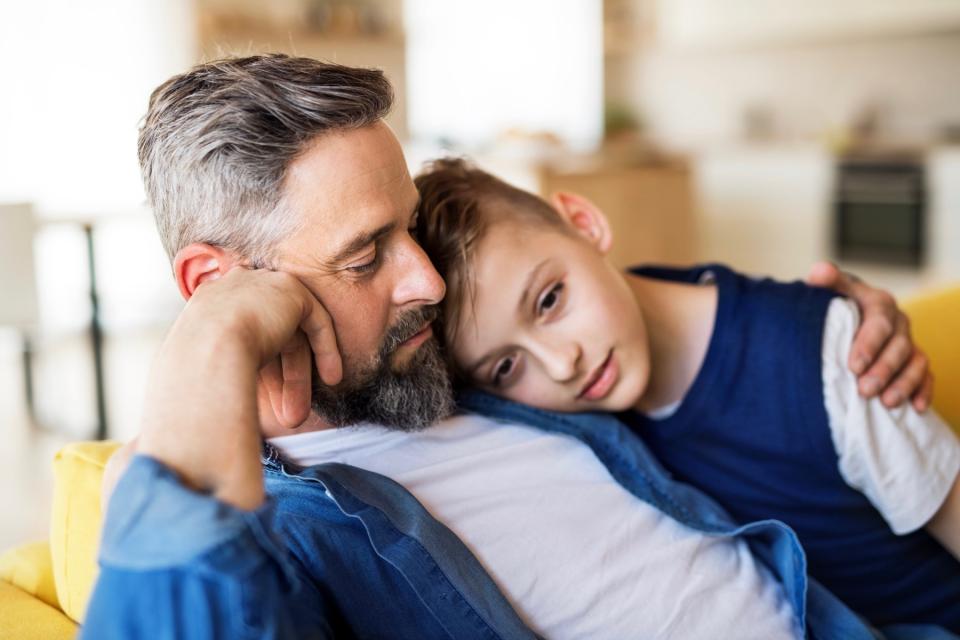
[621,265,960,632]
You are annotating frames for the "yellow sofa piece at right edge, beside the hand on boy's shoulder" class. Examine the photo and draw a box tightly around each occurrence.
[903,284,960,433]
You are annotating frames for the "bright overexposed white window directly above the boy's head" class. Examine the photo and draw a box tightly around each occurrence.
[405,0,603,148]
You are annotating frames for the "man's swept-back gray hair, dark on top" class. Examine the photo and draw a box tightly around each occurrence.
[138,54,393,263]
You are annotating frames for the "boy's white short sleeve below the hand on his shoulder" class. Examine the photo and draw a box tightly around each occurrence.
[823,298,960,535]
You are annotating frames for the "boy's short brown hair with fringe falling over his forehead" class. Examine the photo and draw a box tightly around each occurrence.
[414,158,567,374]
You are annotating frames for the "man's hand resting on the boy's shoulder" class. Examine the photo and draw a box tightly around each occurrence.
[807,262,933,412]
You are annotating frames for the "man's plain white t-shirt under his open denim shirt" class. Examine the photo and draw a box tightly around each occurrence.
[270,415,803,640]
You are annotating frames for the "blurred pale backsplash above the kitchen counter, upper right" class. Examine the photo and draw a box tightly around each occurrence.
[627,34,960,148]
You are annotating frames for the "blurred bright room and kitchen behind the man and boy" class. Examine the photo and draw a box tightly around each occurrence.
[0,0,960,549]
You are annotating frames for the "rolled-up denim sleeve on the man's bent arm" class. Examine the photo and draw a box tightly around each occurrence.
[80,456,332,640]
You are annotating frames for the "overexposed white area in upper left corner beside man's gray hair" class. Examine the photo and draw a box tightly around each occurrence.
[0,0,193,216]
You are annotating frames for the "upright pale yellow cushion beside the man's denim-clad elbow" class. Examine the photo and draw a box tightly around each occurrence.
[50,442,120,622]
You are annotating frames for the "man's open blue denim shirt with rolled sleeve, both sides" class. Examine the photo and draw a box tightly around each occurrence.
[81,393,954,640]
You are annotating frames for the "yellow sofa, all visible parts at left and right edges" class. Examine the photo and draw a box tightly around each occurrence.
[0,285,960,640]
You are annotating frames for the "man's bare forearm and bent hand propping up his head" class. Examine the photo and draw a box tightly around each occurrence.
[136,268,342,509]
